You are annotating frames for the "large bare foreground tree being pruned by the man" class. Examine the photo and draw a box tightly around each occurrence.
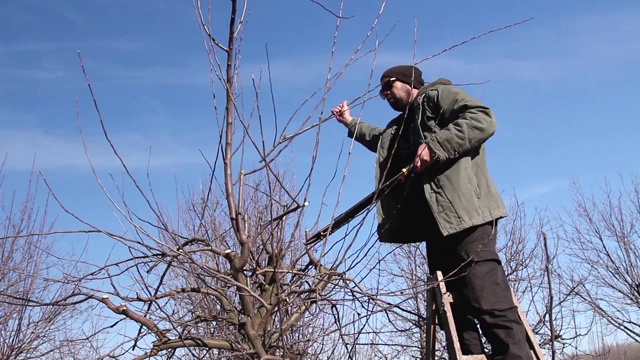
[8,0,396,359]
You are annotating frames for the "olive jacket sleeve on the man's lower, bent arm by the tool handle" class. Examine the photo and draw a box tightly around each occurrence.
[423,86,496,161]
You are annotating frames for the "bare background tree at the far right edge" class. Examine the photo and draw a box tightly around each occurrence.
[561,177,640,342]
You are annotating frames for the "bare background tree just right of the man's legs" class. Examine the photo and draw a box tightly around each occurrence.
[499,197,588,358]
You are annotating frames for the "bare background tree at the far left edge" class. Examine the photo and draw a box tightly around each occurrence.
[0,167,91,360]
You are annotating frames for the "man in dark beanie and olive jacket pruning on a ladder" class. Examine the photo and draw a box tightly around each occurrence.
[332,65,531,360]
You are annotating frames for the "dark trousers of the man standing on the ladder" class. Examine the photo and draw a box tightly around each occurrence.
[427,219,532,360]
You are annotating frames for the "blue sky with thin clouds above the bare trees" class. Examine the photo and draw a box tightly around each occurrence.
[0,0,640,252]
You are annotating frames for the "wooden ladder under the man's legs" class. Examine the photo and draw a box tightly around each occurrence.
[424,271,544,360]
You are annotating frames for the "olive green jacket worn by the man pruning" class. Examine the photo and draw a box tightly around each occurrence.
[348,79,508,243]
